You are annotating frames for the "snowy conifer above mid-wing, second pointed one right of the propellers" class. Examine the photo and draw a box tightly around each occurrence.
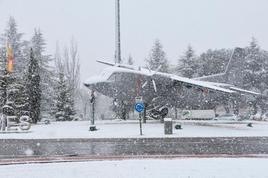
[178,45,197,78]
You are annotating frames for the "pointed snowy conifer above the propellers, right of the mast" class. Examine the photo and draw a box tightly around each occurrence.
[147,40,169,72]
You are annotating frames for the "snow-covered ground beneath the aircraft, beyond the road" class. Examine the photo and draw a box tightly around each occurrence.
[0,120,268,139]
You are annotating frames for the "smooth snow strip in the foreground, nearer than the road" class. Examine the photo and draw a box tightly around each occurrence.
[0,158,268,178]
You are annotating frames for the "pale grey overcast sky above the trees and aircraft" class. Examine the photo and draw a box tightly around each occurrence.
[0,0,268,80]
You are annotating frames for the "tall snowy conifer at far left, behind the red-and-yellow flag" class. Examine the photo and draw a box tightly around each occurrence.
[0,17,28,117]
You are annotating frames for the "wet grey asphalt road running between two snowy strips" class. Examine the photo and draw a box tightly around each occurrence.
[0,137,268,158]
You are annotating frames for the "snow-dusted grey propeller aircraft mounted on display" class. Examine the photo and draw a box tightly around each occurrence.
[84,48,260,119]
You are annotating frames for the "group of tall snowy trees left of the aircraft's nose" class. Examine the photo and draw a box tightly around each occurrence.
[0,17,80,123]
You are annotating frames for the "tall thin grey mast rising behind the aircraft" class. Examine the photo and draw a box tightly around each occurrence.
[115,0,121,63]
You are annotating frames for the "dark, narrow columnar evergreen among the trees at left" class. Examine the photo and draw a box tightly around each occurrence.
[26,49,41,123]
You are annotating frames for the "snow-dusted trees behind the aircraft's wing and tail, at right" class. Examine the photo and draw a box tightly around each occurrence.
[140,37,268,117]
